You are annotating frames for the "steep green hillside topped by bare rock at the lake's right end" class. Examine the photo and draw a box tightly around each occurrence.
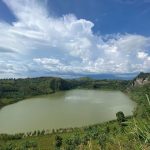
[126,73,150,118]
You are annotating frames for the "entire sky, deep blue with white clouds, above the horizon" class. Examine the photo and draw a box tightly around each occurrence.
[0,0,150,78]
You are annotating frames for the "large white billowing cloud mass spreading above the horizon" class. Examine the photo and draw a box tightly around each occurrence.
[0,0,150,77]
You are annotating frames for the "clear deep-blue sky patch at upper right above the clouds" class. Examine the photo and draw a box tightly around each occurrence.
[48,0,150,35]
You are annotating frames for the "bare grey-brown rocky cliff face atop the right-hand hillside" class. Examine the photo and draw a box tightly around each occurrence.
[132,72,150,87]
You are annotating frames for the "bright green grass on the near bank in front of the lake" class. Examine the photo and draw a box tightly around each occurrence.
[2,118,150,150]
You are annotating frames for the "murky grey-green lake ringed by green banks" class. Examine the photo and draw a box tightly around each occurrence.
[0,89,136,134]
